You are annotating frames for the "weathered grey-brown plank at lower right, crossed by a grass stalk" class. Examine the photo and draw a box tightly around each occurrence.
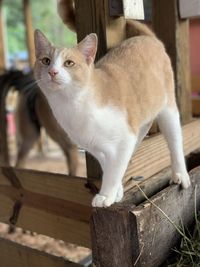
[132,168,200,267]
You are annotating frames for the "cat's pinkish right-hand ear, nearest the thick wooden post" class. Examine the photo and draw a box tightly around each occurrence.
[78,33,98,65]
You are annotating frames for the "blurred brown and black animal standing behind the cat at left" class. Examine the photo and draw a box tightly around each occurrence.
[0,70,78,175]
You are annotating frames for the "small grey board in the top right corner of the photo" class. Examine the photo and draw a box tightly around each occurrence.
[179,0,200,18]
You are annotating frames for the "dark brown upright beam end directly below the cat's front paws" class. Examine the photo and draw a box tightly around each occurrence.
[91,205,138,267]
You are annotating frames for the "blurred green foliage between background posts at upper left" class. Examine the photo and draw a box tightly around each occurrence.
[3,0,76,54]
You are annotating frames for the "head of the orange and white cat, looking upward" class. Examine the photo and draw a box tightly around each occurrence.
[35,30,97,91]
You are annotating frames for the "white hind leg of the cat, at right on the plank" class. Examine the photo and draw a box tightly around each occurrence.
[158,107,190,188]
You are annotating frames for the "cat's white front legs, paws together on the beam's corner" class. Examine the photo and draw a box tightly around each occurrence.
[92,134,137,207]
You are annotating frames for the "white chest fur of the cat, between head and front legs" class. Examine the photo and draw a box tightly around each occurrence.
[41,87,129,155]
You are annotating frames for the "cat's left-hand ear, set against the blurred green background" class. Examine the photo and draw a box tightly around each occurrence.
[34,30,51,57]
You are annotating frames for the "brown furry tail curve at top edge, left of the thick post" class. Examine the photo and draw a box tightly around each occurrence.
[57,0,76,32]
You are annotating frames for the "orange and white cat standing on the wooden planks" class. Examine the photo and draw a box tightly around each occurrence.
[35,21,190,207]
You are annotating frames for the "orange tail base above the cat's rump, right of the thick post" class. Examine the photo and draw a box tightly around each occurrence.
[126,20,155,38]
